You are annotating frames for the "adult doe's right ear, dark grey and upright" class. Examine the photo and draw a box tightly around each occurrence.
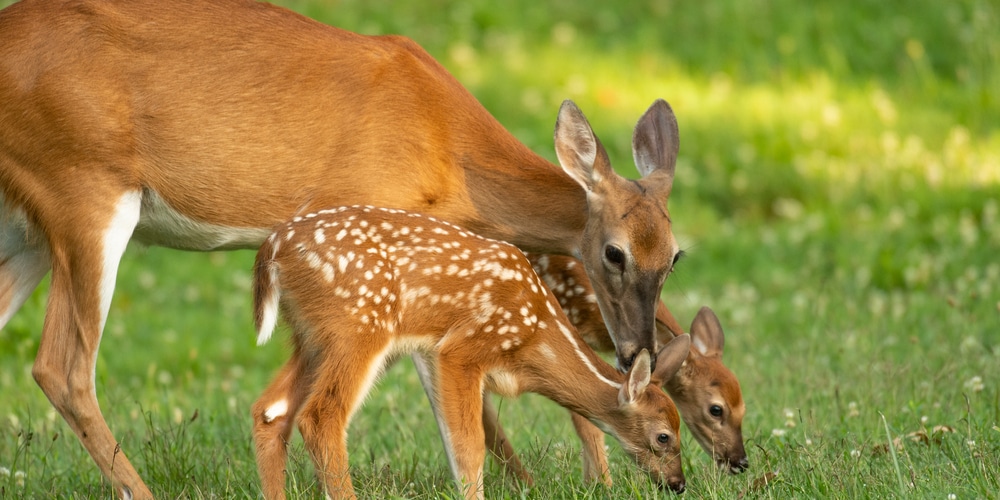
[632,99,680,196]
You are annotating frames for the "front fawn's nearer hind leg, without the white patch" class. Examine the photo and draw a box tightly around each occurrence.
[296,334,390,498]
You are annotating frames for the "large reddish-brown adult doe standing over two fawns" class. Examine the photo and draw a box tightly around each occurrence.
[0,0,678,497]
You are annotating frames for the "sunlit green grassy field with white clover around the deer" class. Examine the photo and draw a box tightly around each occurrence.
[0,0,1000,499]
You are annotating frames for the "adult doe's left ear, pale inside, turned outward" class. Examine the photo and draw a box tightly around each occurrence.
[555,99,616,194]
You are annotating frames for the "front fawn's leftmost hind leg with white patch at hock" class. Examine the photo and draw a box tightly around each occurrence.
[251,350,309,499]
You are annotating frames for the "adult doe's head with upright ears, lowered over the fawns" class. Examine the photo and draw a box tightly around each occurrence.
[555,100,680,372]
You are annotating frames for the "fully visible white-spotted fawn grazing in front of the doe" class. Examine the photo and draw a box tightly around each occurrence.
[252,207,690,498]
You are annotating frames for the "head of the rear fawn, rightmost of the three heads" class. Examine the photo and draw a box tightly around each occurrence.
[664,307,749,474]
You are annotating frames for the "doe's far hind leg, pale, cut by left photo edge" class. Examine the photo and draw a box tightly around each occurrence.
[0,205,49,328]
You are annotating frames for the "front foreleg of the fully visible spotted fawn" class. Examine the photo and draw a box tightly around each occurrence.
[437,357,486,499]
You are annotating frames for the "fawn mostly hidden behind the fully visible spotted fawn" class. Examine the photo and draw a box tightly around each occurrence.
[483,254,749,484]
